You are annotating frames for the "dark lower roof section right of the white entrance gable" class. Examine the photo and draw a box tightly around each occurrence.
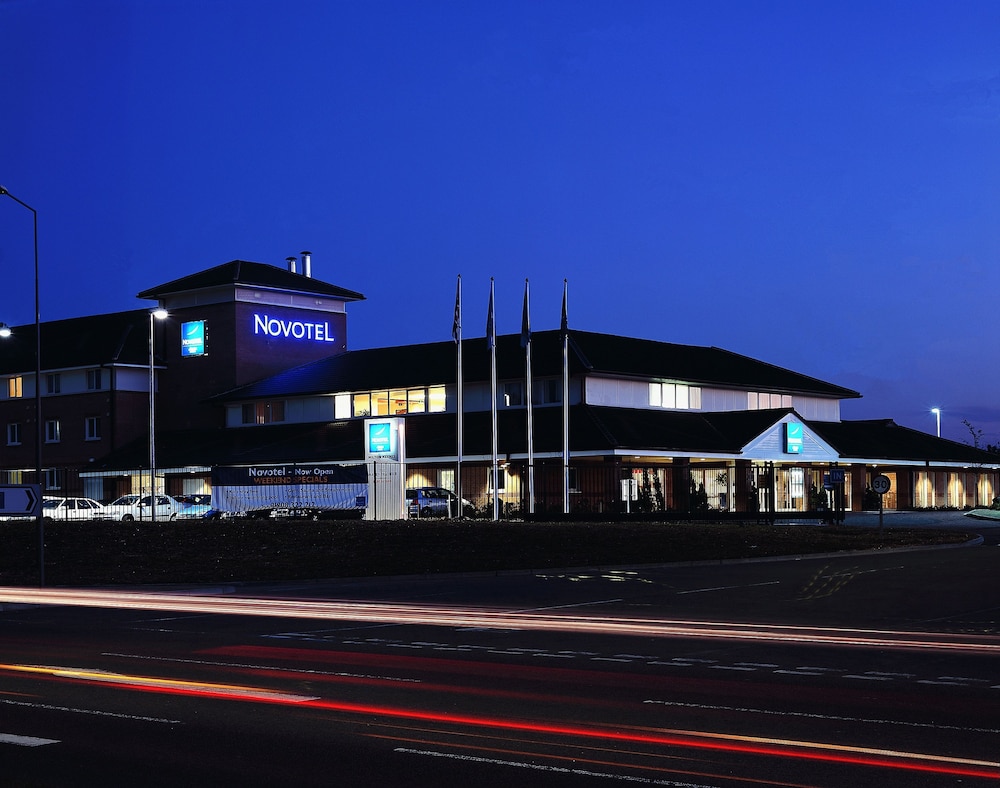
[809,419,1000,465]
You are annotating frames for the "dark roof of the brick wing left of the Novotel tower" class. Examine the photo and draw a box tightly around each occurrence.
[0,309,149,374]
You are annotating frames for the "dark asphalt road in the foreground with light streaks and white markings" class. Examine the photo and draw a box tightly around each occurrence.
[0,521,1000,788]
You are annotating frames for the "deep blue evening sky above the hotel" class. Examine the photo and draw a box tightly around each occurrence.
[0,0,1000,442]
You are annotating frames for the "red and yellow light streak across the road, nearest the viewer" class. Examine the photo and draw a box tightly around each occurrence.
[0,664,1000,781]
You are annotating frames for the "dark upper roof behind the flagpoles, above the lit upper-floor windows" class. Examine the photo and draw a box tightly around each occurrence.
[216,330,860,401]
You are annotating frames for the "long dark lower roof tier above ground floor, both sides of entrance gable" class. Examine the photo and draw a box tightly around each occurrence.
[92,405,1000,470]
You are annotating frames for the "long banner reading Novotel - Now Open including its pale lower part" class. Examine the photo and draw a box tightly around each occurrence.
[212,463,368,512]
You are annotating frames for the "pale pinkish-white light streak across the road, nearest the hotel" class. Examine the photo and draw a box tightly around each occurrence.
[0,588,1000,656]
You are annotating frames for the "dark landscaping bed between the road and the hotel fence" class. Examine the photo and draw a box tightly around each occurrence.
[0,520,971,586]
